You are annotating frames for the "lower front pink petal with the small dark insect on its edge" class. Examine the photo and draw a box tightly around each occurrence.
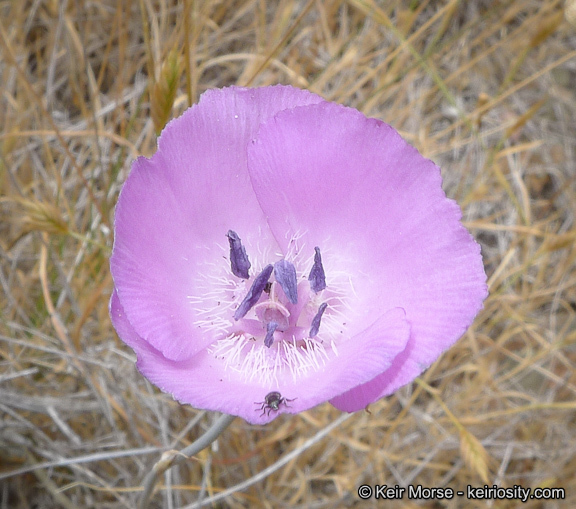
[110,292,410,424]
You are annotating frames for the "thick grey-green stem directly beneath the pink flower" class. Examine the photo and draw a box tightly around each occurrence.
[140,414,236,509]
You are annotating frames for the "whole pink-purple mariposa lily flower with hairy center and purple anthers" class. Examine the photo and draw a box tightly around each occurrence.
[110,86,487,424]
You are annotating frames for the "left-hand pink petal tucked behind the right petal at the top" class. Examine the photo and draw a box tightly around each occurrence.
[110,86,322,360]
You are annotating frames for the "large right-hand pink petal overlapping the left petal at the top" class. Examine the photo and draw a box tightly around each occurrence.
[248,102,487,411]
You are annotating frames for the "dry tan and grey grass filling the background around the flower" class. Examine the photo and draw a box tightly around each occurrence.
[0,0,576,508]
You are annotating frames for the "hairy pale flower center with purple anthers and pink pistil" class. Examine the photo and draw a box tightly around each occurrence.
[189,230,353,380]
